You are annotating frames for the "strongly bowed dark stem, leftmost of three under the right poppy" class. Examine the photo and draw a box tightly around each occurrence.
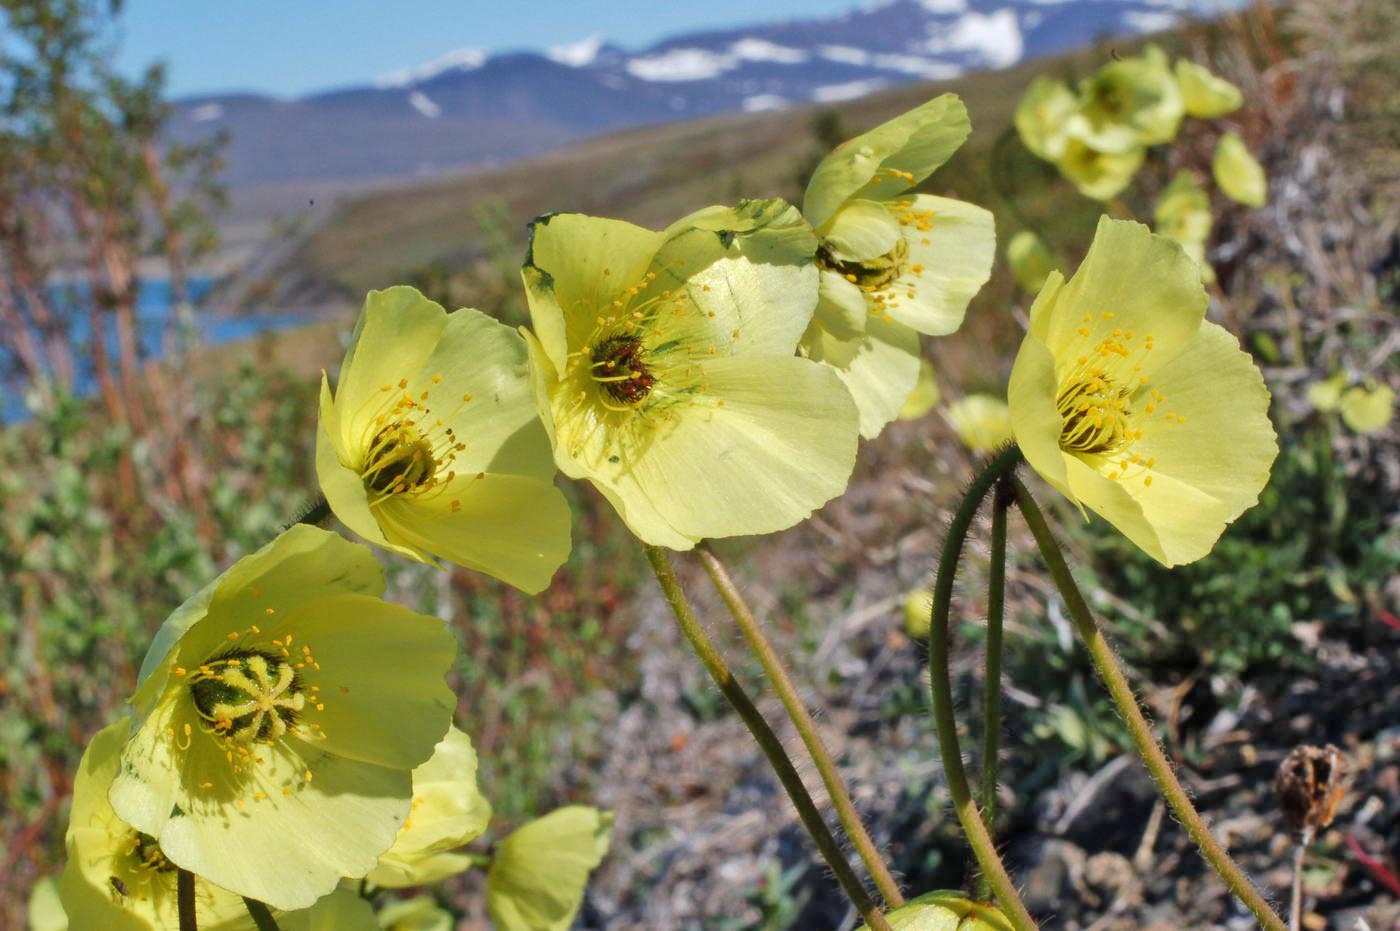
[928,447,1036,931]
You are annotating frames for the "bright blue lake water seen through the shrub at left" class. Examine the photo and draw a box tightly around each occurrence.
[0,277,308,423]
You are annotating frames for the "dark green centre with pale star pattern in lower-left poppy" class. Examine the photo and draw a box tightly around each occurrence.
[189,650,307,743]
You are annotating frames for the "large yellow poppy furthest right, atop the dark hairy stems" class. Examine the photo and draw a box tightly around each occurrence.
[1008,217,1278,566]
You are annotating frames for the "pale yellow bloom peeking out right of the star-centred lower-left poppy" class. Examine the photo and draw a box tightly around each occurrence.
[365,727,491,889]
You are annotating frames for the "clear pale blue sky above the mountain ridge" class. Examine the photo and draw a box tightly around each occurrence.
[119,0,857,97]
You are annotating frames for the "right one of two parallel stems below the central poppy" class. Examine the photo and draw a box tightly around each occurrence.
[697,545,904,909]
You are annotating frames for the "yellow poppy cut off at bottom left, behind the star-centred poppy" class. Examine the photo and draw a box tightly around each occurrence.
[60,718,375,931]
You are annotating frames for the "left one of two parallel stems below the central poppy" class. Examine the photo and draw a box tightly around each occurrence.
[644,546,890,931]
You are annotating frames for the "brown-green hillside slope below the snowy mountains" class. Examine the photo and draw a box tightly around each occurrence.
[298,34,1137,295]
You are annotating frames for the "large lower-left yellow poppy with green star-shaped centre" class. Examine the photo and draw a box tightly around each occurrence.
[111,525,456,909]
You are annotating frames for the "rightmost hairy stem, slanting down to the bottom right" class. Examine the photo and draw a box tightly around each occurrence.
[1012,479,1285,931]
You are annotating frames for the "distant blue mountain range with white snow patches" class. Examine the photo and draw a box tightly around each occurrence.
[172,0,1236,185]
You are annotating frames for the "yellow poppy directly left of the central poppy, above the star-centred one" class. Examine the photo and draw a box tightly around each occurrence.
[316,287,570,592]
